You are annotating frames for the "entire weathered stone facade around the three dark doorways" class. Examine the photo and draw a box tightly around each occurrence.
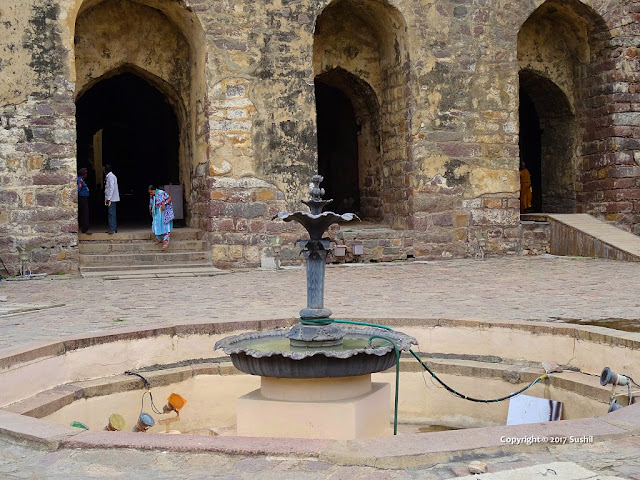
[0,0,640,271]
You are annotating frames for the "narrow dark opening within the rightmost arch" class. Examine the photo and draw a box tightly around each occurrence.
[519,88,542,212]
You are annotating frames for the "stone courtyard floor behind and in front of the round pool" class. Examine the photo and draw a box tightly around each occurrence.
[0,256,640,480]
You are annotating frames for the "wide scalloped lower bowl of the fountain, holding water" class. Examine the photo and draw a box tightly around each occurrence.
[215,327,417,378]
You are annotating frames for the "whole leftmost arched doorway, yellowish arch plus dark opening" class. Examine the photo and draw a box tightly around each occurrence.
[74,0,208,232]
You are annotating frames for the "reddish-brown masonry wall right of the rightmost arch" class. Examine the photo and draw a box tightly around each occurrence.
[578,2,640,234]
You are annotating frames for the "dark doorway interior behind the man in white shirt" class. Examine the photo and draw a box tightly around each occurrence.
[76,72,180,225]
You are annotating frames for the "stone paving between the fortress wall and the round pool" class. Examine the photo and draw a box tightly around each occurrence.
[0,257,640,349]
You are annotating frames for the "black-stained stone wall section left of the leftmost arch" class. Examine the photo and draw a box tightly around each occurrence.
[0,2,78,274]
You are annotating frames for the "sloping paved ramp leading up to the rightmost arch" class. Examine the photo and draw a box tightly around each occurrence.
[547,213,640,262]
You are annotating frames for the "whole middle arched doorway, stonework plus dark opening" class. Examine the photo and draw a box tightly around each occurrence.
[313,0,410,229]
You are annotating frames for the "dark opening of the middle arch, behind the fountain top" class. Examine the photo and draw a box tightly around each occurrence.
[315,79,360,213]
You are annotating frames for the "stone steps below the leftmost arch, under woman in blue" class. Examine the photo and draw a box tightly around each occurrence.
[78,228,217,277]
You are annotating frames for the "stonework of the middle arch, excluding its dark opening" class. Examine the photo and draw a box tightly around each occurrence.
[313,0,410,228]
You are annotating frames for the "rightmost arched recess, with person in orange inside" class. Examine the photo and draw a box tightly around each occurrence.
[517,0,609,213]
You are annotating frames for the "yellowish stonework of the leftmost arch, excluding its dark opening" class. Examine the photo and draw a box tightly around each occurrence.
[73,0,208,226]
